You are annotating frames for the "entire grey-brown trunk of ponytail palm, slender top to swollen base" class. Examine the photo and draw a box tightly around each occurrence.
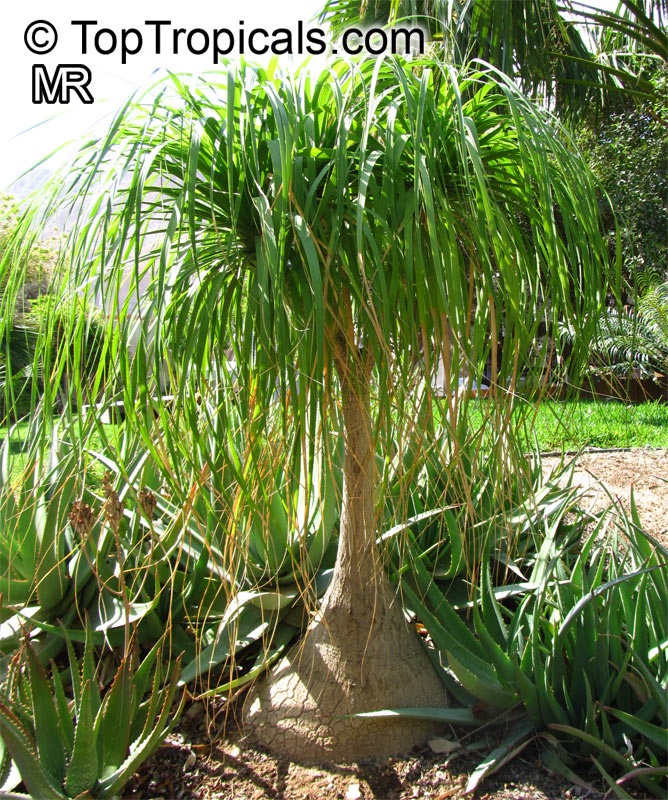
[244,360,445,761]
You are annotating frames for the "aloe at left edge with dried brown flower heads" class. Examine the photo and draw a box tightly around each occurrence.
[0,429,164,661]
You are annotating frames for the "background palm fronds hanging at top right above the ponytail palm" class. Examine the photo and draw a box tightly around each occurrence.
[320,0,668,117]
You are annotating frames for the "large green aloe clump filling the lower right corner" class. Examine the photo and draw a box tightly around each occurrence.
[392,492,668,797]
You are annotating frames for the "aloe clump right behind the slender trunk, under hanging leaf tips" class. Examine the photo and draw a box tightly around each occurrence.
[381,416,569,582]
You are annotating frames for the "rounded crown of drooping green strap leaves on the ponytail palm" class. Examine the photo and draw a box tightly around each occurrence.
[36,59,604,444]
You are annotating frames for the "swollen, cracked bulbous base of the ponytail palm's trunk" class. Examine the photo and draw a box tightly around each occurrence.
[244,575,446,763]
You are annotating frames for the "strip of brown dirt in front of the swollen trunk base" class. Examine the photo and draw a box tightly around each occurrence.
[124,732,594,800]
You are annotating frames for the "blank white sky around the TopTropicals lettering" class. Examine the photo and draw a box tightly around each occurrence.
[0,0,616,191]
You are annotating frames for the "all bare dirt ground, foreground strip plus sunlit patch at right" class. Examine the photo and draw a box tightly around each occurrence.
[125,450,668,800]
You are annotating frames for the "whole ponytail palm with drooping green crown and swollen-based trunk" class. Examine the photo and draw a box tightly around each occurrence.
[24,59,606,760]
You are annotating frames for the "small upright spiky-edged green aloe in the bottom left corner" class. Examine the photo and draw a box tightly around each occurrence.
[0,626,185,800]
